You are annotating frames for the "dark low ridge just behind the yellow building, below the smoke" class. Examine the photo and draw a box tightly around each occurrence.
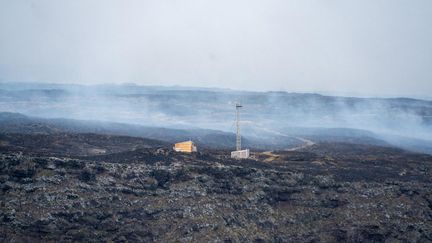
[0,112,301,150]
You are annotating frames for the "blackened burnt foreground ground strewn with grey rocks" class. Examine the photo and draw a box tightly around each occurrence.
[0,134,432,242]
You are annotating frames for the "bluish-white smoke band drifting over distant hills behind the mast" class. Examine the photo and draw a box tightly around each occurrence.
[0,83,432,151]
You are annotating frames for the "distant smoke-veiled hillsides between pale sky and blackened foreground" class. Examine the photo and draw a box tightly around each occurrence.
[0,83,432,153]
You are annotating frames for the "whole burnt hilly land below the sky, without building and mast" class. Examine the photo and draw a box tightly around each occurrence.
[0,85,432,242]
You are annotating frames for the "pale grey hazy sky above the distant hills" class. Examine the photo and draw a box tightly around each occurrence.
[0,0,432,95]
